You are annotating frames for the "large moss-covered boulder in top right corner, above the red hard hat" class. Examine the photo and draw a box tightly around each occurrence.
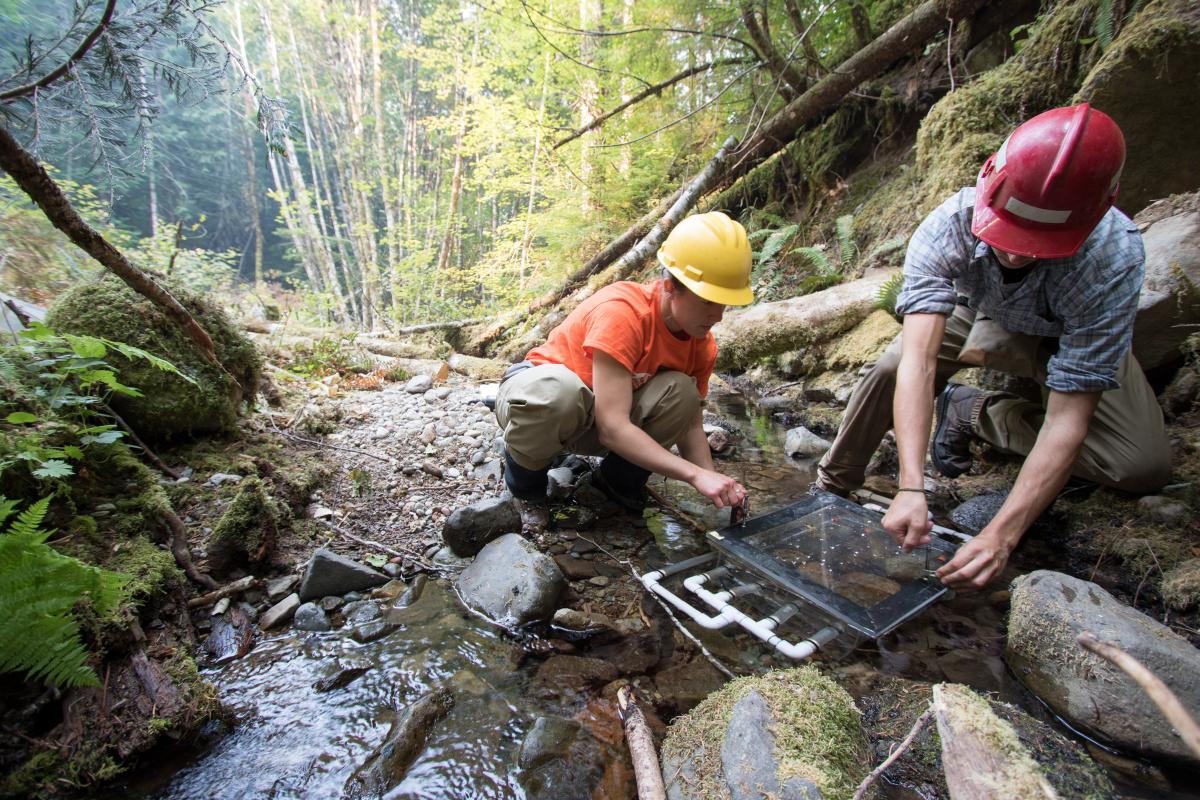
[1075,0,1200,213]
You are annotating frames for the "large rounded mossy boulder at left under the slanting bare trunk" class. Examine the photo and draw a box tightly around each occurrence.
[46,275,262,441]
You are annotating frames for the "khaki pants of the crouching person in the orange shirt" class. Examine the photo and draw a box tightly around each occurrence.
[496,363,701,470]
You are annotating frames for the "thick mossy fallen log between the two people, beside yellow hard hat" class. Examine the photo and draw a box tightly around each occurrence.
[713,272,890,369]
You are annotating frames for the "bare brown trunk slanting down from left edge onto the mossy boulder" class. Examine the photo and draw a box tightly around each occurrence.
[0,128,217,363]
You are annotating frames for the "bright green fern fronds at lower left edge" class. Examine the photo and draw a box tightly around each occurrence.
[0,498,128,687]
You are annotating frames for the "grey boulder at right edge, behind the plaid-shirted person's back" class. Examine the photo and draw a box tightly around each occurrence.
[1133,192,1200,369]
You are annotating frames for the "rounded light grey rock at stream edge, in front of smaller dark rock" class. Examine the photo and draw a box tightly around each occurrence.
[456,534,566,625]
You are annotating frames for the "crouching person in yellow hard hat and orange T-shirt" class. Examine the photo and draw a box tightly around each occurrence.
[496,211,754,533]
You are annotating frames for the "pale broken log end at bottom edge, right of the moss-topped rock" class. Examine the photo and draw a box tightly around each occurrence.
[934,684,1058,800]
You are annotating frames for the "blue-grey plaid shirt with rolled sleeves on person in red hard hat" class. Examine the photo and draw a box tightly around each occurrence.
[896,188,1145,392]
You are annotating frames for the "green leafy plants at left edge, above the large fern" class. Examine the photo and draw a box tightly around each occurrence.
[0,323,194,481]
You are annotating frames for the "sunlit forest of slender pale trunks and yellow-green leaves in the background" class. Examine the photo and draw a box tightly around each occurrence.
[0,0,904,330]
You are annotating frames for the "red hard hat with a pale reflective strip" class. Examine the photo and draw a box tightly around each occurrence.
[971,103,1124,258]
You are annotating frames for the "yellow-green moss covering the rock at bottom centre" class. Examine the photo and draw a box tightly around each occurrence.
[662,667,870,800]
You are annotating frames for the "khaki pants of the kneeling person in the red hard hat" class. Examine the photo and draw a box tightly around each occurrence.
[817,306,1171,493]
